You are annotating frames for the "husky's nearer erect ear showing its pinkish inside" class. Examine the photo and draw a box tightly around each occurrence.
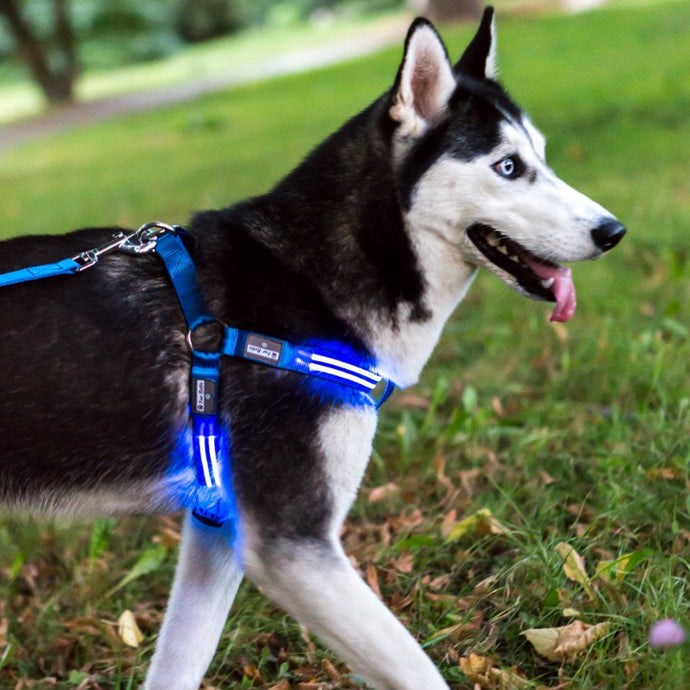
[390,19,455,135]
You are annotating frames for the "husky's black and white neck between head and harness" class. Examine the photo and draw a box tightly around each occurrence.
[231,99,474,387]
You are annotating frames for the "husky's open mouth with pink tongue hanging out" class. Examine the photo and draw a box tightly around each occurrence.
[467,223,576,322]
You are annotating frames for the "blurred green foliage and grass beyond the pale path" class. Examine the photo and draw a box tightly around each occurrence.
[0,0,405,88]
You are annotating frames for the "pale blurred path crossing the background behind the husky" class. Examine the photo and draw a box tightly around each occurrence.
[0,17,409,153]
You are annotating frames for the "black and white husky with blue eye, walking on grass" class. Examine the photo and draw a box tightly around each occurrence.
[0,9,625,690]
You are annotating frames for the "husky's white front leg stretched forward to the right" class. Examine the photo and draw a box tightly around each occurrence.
[245,539,448,690]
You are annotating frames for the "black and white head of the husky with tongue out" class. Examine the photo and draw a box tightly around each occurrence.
[389,8,625,321]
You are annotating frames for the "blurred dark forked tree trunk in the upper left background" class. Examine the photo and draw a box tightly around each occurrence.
[0,0,79,104]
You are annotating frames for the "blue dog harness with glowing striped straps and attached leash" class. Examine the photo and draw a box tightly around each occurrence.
[0,222,395,527]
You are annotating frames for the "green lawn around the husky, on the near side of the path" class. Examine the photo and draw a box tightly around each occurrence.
[0,3,690,690]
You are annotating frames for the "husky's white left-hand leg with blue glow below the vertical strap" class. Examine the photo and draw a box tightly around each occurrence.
[144,515,242,690]
